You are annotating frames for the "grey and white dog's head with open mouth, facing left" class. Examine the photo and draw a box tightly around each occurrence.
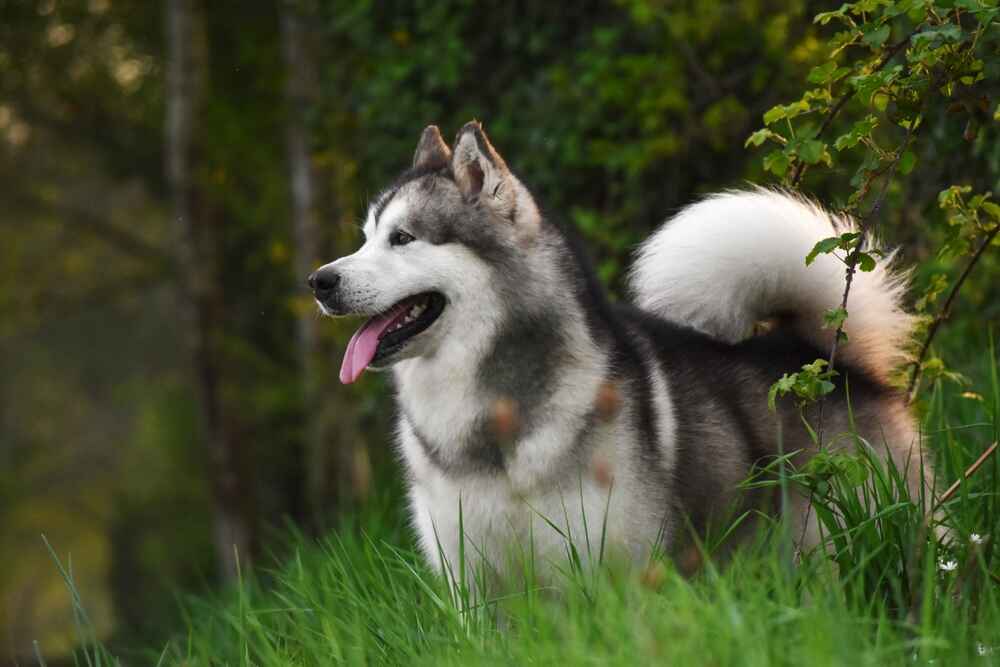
[309,121,542,383]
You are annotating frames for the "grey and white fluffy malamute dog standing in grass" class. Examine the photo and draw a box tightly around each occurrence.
[308,121,924,574]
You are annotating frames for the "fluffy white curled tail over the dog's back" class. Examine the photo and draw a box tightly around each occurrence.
[631,190,914,381]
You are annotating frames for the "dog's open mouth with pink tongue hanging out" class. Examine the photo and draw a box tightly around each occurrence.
[340,292,445,384]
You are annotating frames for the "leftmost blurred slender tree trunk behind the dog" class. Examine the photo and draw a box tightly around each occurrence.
[166,0,255,578]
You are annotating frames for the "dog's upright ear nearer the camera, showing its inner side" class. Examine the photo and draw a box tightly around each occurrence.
[451,120,540,228]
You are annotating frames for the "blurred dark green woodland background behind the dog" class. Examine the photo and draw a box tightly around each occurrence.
[0,0,1000,664]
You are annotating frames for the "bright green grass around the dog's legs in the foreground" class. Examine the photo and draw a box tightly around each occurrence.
[56,355,1000,666]
